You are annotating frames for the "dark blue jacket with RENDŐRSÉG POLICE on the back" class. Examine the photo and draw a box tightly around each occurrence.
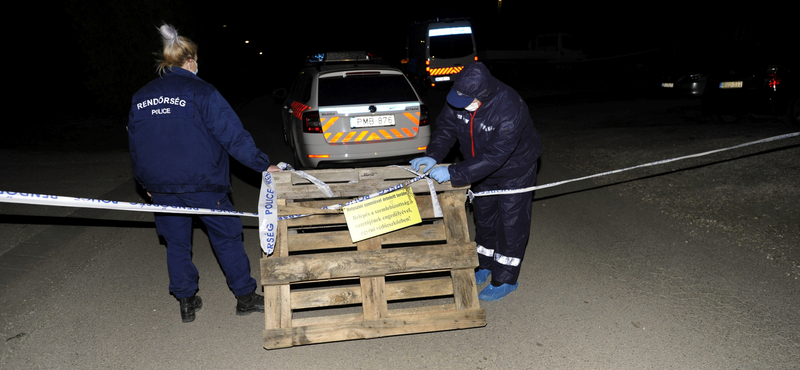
[128,68,269,193]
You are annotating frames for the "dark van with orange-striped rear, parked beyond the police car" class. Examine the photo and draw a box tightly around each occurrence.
[403,18,478,88]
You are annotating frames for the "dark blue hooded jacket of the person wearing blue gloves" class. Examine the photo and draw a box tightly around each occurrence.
[425,62,542,191]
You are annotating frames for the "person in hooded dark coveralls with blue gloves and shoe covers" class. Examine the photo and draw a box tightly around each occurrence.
[411,62,542,301]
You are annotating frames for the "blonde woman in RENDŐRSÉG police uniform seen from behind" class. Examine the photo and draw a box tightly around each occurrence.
[128,24,280,322]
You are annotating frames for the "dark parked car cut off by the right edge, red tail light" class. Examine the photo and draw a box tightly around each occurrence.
[703,44,800,126]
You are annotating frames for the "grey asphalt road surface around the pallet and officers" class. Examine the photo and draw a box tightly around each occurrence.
[0,82,800,369]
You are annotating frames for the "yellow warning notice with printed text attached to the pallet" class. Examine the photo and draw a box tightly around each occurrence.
[343,188,422,243]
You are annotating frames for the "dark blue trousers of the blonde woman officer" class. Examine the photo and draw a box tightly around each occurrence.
[152,192,256,298]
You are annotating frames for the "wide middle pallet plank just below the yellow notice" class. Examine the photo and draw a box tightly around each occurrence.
[261,243,478,285]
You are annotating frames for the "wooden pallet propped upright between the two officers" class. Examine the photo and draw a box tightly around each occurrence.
[261,167,486,349]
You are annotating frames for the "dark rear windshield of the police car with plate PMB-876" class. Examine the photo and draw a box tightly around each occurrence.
[318,75,417,106]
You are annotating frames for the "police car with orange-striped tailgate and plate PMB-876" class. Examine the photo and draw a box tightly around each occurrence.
[282,52,430,168]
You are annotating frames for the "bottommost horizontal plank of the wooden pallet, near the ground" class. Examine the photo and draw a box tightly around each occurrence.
[263,309,486,349]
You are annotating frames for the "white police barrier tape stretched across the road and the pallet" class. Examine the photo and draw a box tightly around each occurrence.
[0,132,800,254]
